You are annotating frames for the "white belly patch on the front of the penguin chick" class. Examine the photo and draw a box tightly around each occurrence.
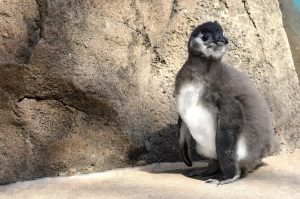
[176,84,217,159]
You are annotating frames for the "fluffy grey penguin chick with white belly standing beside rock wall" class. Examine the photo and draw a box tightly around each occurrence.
[175,22,279,184]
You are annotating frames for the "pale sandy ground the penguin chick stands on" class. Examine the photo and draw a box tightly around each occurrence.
[0,150,300,199]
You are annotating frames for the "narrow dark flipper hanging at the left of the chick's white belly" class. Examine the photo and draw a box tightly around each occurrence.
[177,117,193,167]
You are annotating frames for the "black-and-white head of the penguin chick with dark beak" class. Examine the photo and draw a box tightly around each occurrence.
[188,22,228,60]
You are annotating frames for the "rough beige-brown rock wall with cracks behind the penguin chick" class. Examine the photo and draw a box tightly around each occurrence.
[0,0,300,184]
